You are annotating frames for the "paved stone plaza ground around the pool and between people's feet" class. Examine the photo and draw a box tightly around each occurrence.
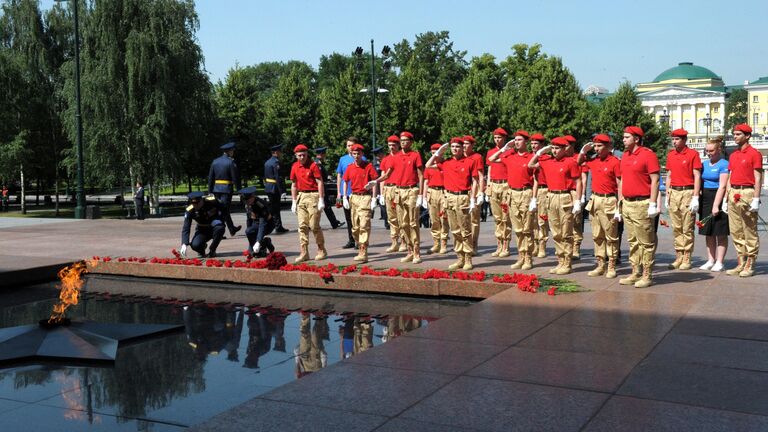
[0,210,768,431]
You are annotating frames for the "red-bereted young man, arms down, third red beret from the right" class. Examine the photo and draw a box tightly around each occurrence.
[619,126,660,288]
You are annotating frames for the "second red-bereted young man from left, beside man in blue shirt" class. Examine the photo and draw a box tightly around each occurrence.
[342,143,378,262]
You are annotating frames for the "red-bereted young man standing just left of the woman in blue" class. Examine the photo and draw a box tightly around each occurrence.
[665,129,702,270]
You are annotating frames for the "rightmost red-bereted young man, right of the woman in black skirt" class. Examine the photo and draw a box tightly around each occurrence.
[723,124,763,277]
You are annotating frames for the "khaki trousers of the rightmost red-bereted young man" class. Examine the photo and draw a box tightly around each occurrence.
[728,188,760,258]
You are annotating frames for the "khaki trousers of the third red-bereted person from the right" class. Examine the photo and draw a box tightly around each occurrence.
[621,199,657,268]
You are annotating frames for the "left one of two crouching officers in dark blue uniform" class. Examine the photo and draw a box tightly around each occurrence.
[179,192,224,258]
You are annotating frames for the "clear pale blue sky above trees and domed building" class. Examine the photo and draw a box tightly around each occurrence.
[41,0,768,90]
